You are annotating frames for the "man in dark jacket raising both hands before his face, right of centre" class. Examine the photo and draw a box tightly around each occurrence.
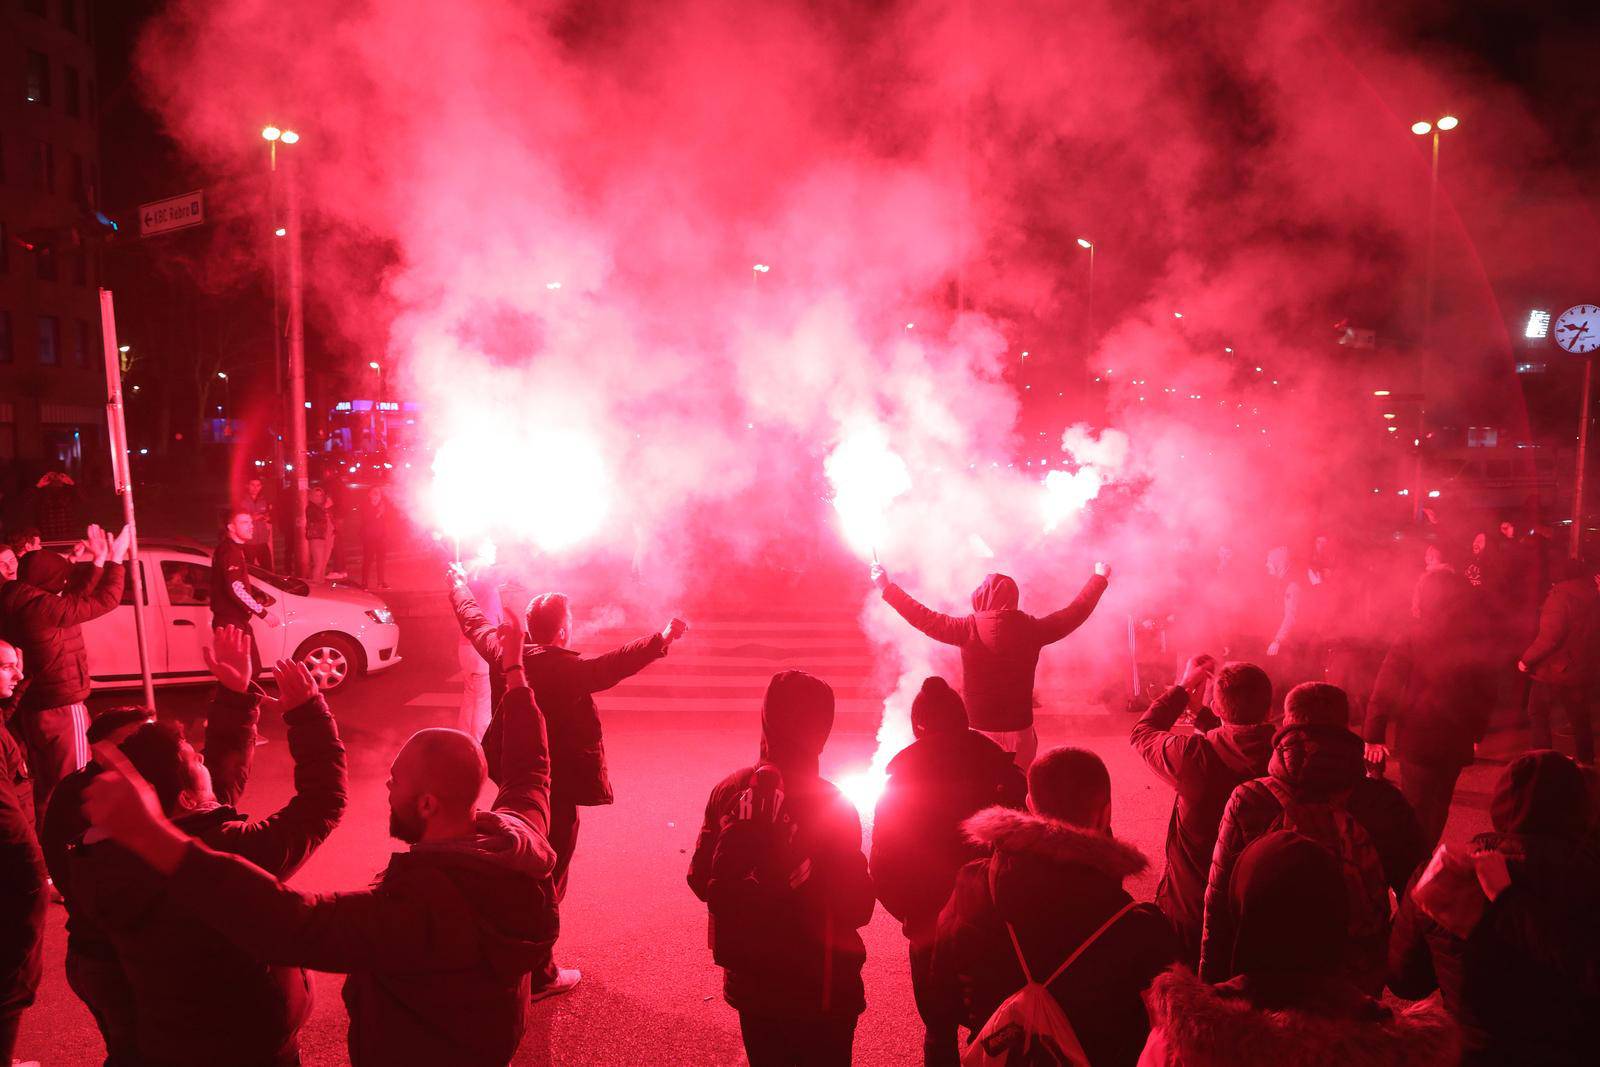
[1130,656,1274,968]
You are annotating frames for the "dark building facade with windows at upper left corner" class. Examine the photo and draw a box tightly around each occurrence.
[0,0,109,499]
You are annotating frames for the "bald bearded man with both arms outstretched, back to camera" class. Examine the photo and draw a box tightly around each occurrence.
[85,613,563,1067]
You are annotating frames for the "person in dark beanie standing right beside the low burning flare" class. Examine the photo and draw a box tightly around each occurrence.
[872,678,1027,1067]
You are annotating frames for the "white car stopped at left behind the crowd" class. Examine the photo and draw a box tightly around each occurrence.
[55,541,400,693]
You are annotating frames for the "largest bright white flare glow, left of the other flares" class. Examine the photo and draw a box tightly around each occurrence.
[429,426,611,552]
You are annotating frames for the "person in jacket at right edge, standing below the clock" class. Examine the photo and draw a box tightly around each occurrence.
[1517,563,1600,768]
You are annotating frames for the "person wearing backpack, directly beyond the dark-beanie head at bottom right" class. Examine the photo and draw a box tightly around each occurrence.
[1200,681,1427,995]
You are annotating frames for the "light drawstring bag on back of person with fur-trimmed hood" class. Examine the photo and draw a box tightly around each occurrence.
[962,853,1138,1067]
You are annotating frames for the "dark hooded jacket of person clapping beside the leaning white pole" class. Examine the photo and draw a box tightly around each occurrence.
[0,549,123,715]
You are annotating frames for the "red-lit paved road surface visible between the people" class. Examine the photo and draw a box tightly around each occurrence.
[18,563,1518,1067]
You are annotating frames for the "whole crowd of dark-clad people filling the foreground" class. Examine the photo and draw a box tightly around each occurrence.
[0,507,1600,1067]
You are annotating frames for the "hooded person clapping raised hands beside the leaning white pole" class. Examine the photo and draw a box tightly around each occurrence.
[0,526,131,821]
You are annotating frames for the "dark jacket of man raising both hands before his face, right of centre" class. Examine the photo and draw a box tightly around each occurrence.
[1130,686,1274,966]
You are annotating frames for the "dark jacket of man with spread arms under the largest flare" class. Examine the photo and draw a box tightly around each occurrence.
[450,585,667,806]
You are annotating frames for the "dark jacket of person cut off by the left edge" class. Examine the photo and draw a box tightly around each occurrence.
[0,726,50,1016]
